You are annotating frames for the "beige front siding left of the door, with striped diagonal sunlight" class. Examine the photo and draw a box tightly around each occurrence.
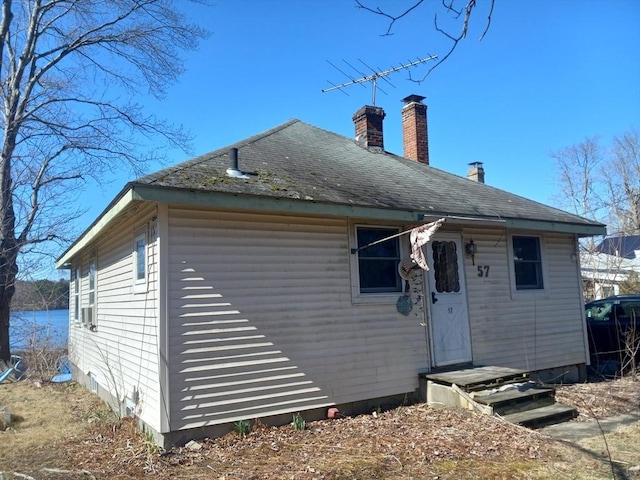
[168,207,428,430]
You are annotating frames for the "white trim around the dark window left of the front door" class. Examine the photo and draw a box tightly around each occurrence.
[349,222,408,305]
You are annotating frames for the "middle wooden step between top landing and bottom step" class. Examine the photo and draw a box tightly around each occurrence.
[473,384,555,416]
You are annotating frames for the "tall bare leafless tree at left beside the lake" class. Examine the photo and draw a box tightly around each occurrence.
[0,0,205,365]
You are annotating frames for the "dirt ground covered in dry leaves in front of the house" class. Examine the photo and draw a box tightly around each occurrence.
[0,379,640,480]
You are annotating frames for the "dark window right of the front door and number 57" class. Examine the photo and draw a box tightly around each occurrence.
[511,235,544,290]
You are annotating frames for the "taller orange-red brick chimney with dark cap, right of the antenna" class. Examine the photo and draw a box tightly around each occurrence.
[402,95,429,165]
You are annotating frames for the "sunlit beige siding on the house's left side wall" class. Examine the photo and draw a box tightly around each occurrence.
[69,205,160,429]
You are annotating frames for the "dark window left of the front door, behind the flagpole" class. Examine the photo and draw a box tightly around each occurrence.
[356,226,402,294]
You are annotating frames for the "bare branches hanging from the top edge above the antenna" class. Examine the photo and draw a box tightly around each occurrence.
[355,0,495,82]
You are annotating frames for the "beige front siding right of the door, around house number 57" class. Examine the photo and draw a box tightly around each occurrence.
[464,229,586,370]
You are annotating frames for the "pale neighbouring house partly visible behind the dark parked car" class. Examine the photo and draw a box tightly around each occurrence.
[580,235,640,300]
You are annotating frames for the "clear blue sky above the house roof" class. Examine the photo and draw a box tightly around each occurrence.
[57,0,640,274]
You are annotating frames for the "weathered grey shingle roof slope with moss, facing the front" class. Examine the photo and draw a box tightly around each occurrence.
[132,120,600,226]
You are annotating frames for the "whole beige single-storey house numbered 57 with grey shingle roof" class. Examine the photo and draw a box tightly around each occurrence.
[53,96,605,444]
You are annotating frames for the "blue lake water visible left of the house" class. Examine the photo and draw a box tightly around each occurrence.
[9,310,69,350]
